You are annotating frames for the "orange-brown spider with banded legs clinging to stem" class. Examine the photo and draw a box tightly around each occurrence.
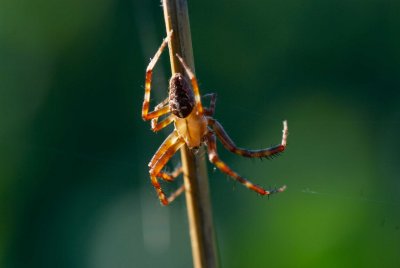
[142,31,288,205]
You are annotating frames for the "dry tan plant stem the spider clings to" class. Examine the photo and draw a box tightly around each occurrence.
[162,0,218,268]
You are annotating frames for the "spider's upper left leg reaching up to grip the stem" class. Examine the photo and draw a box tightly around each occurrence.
[142,30,172,120]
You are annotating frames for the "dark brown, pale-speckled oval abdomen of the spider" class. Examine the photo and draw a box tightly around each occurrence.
[169,73,195,118]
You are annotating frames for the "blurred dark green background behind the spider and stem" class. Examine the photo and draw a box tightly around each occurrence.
[0,0,400,268]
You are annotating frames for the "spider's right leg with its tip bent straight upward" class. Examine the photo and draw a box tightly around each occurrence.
[208,117,288,158]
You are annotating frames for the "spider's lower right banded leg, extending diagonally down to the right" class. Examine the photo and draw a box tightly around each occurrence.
[206,132,286,195]
